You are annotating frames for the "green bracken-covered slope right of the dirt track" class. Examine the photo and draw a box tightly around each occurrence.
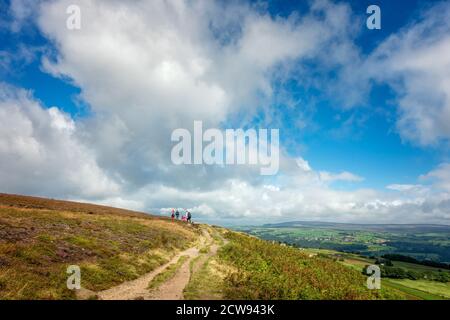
[220,232,402,300]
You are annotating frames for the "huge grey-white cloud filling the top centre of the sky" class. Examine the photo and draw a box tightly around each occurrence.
[33,1,366,189]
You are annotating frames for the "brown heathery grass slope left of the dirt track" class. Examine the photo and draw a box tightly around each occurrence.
[0,194,199,299]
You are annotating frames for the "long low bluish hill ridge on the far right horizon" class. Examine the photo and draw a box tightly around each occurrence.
[263,221,450,233]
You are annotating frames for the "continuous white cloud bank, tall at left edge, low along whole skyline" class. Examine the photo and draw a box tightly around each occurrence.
[0,81,450,223]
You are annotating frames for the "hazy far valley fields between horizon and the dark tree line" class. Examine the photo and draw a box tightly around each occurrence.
[238,222,450,263]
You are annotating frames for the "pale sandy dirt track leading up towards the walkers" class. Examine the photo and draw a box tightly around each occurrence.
[96,230,218,300]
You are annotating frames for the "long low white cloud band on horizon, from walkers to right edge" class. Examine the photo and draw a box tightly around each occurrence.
[97,168,450,224]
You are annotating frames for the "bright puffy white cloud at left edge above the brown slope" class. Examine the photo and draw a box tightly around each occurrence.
[0,84,120,199]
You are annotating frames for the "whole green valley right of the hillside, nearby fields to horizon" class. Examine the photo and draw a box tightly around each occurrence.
[240,222,450,300]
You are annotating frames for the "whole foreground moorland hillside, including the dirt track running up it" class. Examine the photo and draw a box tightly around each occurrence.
[0,194,401,299]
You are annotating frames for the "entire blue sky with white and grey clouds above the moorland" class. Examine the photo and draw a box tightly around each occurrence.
[0,0,450,225]
